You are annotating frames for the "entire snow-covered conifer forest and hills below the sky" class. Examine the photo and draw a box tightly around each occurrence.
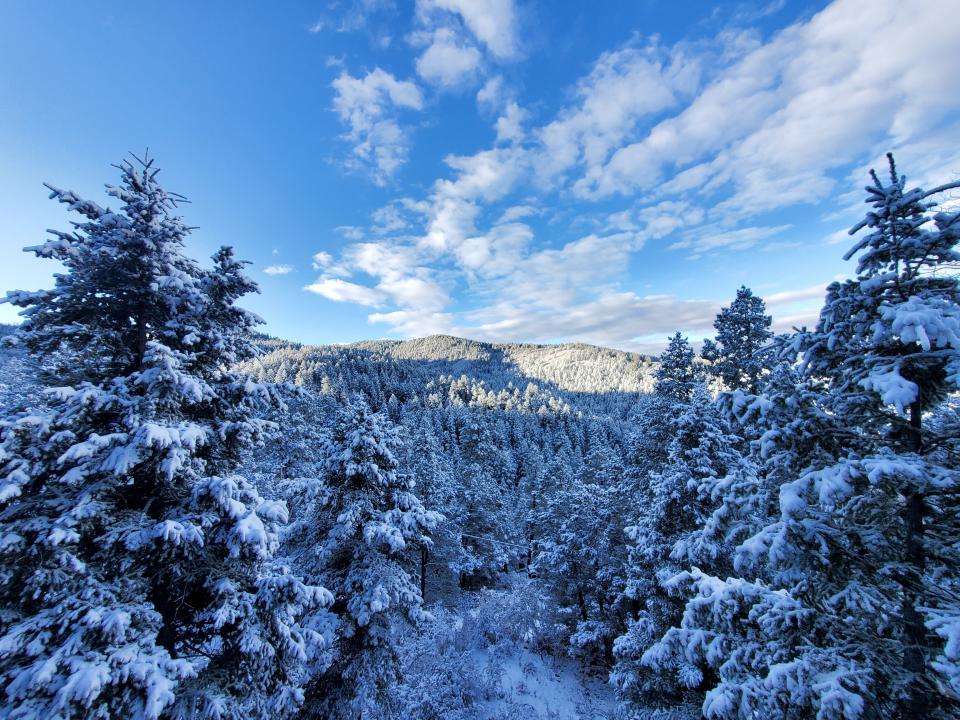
[0,157,960,720]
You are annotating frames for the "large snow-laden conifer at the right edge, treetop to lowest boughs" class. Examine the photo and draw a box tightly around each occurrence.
[644,158,960,720]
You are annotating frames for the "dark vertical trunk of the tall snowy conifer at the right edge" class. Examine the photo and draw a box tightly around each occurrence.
[901,400,931,718]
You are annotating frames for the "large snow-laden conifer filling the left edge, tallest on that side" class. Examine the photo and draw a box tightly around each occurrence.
[0,159,330,720]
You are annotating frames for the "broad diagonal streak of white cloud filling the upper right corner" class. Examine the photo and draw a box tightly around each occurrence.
[579,0,960,217]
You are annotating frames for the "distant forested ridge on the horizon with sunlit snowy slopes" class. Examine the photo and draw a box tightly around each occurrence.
[240,335,655,418]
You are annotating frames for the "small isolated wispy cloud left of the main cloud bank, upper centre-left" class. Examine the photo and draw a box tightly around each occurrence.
[333,68,423,185]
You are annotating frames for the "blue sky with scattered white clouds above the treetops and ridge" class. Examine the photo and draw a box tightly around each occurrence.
[0,0,960,351]
